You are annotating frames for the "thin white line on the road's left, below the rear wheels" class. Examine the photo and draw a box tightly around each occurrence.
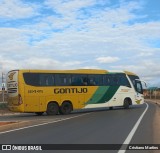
[0,113,90,134]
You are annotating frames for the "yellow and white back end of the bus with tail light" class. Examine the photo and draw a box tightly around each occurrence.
[7,70,24,112]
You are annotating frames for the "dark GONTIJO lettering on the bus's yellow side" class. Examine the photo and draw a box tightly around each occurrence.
[54,88,88,94]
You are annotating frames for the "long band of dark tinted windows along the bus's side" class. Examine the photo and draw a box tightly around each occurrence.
[23,73,131,87]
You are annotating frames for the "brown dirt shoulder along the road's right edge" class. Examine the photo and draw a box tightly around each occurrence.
[145,99,160,144]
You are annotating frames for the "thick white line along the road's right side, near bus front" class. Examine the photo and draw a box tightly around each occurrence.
[118,103,149,153]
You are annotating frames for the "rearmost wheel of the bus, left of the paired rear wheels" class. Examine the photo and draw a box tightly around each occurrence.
[46,102,59,115]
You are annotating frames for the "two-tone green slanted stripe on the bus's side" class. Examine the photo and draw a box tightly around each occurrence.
[86,86,119,104]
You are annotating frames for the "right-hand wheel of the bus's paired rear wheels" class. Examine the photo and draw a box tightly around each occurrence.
[59,102,73,115]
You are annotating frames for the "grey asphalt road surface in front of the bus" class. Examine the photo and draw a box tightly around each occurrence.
[0,103,155,153]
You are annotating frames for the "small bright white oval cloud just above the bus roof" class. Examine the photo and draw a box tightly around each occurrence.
[96,56,119,63]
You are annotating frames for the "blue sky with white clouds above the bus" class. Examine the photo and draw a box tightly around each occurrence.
[0,0,160,87]
